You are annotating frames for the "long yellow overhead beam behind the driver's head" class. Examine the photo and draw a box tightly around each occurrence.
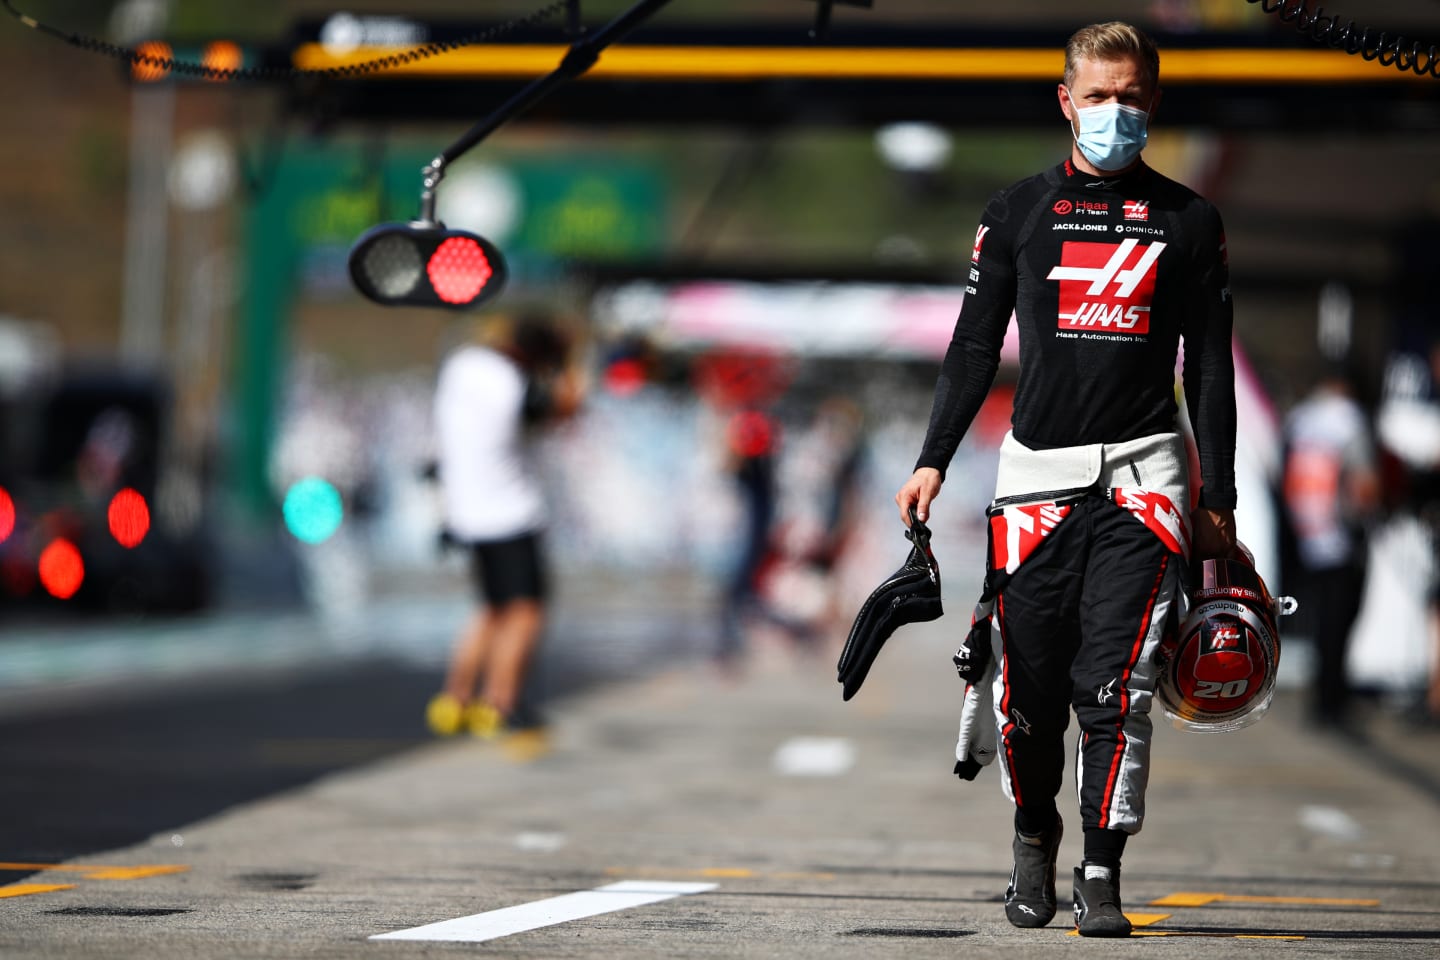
[294,43,1436,85]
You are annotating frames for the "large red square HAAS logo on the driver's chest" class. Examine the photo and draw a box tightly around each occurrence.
[1048,239,1165,334]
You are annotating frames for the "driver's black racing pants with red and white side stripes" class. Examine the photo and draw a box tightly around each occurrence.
[995,497,1181,833]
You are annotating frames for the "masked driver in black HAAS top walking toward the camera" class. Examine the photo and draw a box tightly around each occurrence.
[896,23,1237,937]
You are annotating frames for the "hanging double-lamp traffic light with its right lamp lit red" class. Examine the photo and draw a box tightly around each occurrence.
[350,223,508,309]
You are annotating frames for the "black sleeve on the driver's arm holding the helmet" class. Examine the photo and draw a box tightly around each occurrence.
[1184,204,1236,510]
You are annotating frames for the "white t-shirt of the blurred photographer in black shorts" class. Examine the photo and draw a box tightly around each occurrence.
[435,345,544,541]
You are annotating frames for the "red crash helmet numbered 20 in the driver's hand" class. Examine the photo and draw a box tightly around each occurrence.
[1156,545,1295,733]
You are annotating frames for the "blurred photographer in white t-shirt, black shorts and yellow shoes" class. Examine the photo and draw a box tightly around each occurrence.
[426,312,583,737]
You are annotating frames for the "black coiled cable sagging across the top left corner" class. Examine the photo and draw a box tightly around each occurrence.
[0,0,569,81]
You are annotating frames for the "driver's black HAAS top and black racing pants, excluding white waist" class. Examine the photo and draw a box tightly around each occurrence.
[916,161,1236,846]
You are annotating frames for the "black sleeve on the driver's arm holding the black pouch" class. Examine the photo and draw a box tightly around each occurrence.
[914,193,1024,478]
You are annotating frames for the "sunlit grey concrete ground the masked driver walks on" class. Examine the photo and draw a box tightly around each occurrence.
[0,620,1440,960]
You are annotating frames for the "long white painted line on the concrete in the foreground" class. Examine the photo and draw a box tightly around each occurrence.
[370,879,719,943]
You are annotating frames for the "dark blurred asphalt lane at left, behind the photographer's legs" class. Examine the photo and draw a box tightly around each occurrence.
[0,569,713,882]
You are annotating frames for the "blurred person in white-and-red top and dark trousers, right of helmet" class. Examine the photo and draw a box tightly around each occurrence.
[1282,366,1381,727]
